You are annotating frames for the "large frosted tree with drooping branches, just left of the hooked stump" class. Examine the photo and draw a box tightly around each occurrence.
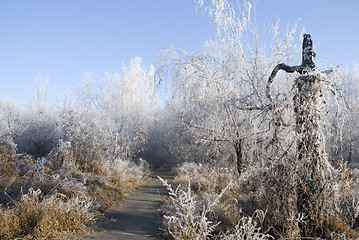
[159,0,298,172]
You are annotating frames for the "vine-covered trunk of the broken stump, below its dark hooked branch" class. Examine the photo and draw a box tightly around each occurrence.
[293,73,328,236]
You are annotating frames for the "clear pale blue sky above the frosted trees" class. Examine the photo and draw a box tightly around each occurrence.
[0,0,359,102]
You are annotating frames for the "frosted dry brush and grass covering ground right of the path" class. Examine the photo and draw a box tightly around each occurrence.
[163,160,359,239]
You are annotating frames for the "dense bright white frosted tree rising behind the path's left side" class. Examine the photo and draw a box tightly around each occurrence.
[71,58,159,164]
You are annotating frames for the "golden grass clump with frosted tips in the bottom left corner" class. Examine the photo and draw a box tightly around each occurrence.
[0,189,95,239]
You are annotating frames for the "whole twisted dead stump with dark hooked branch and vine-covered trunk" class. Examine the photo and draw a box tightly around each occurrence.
[266,34,330,237]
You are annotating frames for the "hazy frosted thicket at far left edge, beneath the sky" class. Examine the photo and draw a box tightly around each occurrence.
[0,95,62,157]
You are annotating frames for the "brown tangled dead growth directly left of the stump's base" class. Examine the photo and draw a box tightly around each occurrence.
[239,161,305,238]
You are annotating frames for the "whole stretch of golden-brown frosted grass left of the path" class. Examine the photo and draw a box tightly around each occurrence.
[0,143,148,240]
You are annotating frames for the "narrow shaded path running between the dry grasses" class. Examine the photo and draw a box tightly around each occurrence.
[73,169,173,240]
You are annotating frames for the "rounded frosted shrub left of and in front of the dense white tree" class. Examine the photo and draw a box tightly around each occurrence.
[57,109,111,173]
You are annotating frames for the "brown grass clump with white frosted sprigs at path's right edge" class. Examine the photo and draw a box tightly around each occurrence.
[162,163,248,239]
